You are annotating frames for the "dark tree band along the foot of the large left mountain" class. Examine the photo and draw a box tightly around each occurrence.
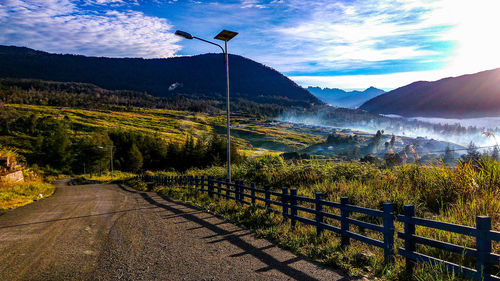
[0,78,287,117]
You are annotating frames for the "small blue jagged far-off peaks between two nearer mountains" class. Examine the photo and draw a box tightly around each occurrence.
[307,87,385,108]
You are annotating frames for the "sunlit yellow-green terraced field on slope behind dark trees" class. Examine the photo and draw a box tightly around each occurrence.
[4,104,328,156]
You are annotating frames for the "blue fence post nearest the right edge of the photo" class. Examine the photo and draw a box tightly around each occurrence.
[476,216,491,280]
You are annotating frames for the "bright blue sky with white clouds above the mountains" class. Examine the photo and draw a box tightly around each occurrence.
[0,0,500,90]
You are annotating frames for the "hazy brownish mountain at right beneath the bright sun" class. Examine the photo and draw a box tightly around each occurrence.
[360,68,500,118]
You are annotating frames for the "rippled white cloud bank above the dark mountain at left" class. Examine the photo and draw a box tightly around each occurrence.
[0,0,180,58]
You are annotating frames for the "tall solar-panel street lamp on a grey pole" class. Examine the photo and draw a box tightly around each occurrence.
[175,29,238,182]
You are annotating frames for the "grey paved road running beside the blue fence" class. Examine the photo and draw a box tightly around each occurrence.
[0,182,348,280]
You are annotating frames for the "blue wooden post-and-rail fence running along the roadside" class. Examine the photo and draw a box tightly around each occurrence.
[138,175,500,281]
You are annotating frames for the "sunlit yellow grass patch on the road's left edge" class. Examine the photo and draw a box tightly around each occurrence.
[0,180,55,209]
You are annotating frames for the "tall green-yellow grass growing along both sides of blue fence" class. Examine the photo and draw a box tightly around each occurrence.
[131,157,500,280]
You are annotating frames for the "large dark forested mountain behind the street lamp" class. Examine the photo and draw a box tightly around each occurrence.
[0,46,323,107]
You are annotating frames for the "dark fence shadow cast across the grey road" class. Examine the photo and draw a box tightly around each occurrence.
[135,187,338,280]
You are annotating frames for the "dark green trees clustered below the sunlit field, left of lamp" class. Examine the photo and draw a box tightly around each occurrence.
[0,105,243,174]
